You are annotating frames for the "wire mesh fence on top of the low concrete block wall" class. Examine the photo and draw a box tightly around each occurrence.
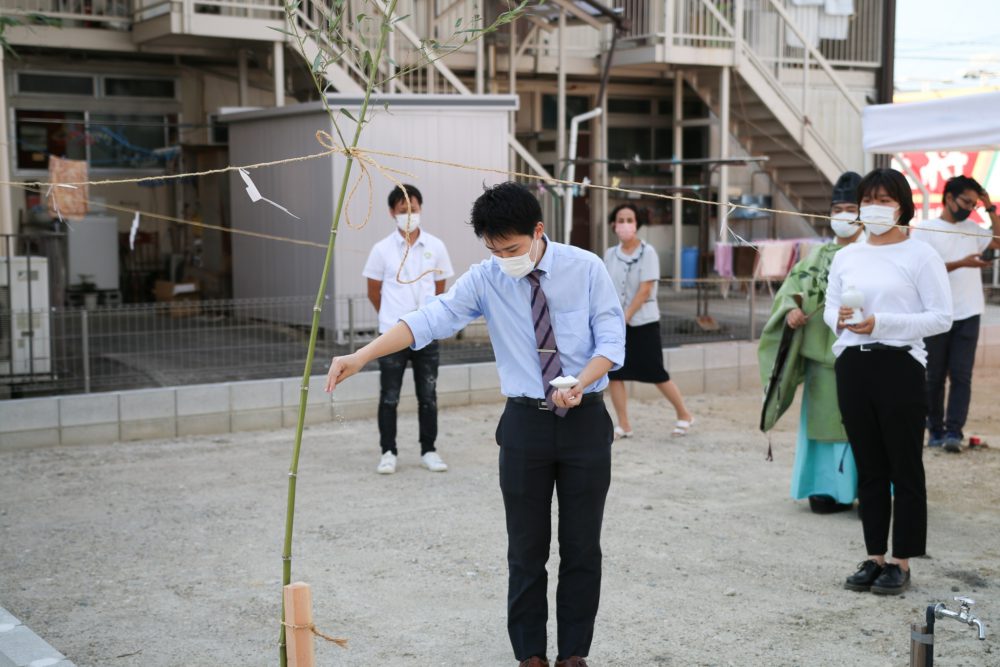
[0,280,776,398]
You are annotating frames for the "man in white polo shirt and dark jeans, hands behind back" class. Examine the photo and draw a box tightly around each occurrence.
[362,184,455,475]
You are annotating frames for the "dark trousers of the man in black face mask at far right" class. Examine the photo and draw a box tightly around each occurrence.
[924,315,979,438]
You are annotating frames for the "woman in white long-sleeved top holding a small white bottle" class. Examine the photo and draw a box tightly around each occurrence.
[823,169,952,594]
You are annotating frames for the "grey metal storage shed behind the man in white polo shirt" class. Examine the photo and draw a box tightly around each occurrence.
[223,94,517,332]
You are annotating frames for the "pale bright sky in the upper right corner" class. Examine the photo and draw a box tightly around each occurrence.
[896,0,1000,91]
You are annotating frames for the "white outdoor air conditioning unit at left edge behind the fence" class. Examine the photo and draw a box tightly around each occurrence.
[0,257,52,377]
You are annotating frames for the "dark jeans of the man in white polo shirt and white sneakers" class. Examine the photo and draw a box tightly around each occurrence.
[378,342,440,455]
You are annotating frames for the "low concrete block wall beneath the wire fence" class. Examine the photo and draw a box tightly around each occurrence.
[0,324,1000,449]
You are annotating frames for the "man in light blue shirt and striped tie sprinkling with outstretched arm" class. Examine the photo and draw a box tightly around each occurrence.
[327,183,625,667]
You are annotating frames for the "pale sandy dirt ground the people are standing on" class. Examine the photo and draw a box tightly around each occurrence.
[0,372,1000,667]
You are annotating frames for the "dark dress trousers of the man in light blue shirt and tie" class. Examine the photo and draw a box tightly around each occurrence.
[496,401,614,660]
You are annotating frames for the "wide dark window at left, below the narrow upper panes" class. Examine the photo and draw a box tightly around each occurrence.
[15,109,176,169]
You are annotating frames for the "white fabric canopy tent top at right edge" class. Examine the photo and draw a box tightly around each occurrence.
[861,92,1000,153]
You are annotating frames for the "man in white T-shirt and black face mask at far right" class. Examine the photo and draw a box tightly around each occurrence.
[910,176,1000,452]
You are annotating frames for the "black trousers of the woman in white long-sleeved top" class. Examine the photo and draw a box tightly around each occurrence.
[834,347,927,558]
